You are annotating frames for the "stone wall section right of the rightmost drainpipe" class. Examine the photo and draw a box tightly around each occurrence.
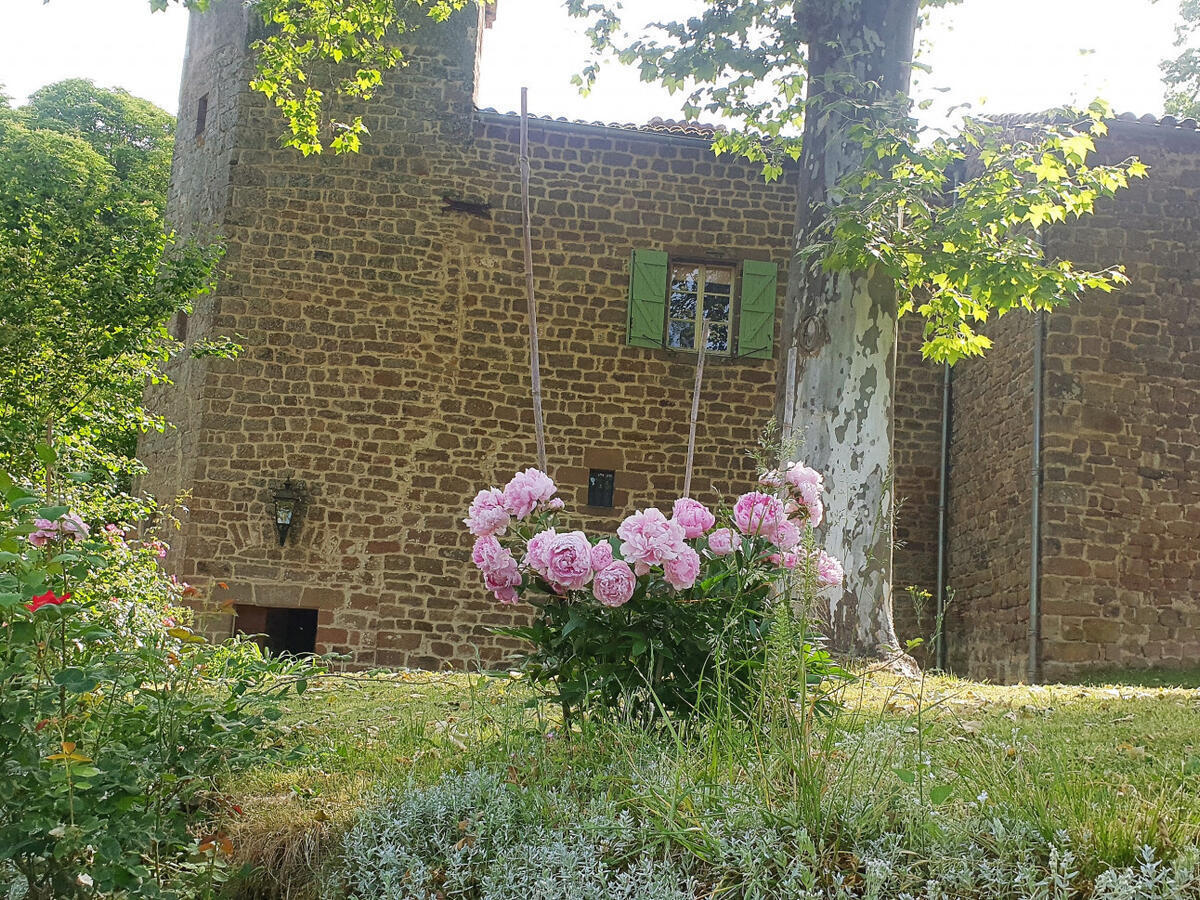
[1042,121,1200,678]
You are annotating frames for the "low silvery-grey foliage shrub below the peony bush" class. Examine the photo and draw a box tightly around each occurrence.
[329,770,697,900]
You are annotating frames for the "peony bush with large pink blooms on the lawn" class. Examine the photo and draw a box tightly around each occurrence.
[463,462,844,720]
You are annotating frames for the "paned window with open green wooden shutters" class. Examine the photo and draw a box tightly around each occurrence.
[628,250,778,359]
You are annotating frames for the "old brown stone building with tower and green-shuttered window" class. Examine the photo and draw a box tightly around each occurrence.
[142,4,1200,679]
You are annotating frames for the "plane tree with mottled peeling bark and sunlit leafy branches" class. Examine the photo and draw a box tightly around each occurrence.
[568,0,1145,655]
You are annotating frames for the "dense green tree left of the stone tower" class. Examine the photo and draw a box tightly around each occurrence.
[0,82,217,513]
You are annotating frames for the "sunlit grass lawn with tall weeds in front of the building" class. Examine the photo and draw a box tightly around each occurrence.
[227,672,1200,900]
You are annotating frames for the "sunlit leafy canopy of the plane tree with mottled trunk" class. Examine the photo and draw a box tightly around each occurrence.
[566,0,1147,362]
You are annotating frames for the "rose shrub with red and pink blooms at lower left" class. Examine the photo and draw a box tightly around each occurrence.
[0,478,308,900]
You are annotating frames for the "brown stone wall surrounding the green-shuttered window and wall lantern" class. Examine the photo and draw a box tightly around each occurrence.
[145,5,816,667]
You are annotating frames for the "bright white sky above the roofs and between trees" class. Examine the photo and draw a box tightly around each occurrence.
[0,0,1177,128]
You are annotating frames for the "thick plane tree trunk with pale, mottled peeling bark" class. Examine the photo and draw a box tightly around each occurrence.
[778,0,918,656]
